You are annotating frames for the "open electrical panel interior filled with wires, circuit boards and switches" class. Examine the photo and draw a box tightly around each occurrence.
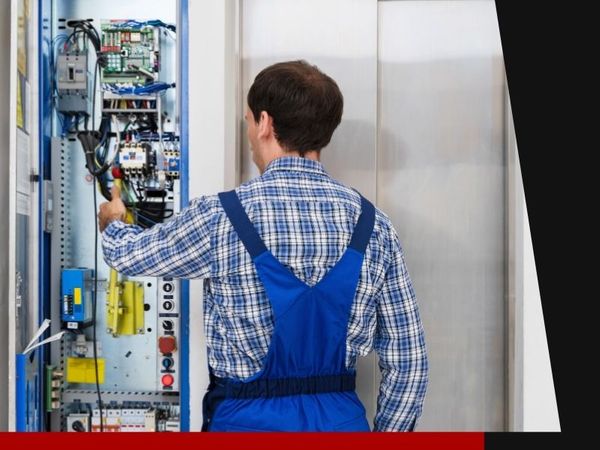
[44,0,185,432]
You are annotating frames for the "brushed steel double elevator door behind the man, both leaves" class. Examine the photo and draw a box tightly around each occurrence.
[240,0,506,431]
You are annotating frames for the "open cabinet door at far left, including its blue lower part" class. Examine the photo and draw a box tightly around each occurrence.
[7,0,42,431]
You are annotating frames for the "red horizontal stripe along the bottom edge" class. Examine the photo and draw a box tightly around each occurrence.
[0,432,484,450]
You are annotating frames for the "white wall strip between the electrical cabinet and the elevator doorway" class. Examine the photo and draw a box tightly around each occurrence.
[188,0,238,431]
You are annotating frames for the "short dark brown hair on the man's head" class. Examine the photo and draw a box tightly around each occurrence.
[248,60,344,154]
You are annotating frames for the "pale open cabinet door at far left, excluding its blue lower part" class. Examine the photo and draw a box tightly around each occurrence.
[7,0,38,429]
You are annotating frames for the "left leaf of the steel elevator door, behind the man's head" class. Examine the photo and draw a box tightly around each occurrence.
[240,0,378,420]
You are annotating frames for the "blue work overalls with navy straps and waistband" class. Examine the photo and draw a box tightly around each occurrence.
[203,191,375,431]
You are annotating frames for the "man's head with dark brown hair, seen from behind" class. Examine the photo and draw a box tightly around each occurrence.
[246,61,344,172]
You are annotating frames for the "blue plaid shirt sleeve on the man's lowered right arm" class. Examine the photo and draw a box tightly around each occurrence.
[374,228,428,431]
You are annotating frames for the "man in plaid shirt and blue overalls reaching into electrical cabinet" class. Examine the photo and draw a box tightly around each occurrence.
[98,61,428,431]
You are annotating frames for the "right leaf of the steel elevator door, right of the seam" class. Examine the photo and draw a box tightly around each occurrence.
[378,1,506,431]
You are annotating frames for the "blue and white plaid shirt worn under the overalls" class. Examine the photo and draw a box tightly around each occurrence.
[102,157,428,431]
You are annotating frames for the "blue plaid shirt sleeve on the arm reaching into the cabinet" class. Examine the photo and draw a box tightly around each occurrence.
[102,197,215,278]
